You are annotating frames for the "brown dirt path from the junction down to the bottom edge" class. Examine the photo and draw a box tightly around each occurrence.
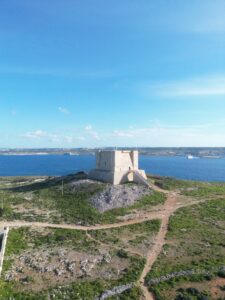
[139,193,177,300]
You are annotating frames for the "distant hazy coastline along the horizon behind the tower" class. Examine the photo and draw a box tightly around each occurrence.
[0,147,225,158]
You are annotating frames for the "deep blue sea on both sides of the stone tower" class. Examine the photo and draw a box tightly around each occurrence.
[0,155,225,182]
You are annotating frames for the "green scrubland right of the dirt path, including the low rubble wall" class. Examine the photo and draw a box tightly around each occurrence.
[146,199,225,300]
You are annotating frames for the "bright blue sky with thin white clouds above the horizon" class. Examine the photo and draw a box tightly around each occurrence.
[0,0,225,148]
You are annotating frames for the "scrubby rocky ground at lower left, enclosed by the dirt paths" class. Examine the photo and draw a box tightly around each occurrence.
[0,220,155,300]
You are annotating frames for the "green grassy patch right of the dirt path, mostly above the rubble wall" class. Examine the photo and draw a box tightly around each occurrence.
[146,199,225,299]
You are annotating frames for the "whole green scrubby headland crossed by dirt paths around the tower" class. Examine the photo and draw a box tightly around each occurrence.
[0,173,225,300]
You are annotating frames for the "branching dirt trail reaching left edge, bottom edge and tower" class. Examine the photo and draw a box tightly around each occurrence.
[0,184,183,300]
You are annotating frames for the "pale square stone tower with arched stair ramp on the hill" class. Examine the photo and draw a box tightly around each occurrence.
[89,150,148,186]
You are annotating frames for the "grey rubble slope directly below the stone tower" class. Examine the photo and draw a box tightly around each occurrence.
[90,184,152,212]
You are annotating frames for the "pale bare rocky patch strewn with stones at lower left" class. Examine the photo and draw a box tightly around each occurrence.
[4,247,121,290]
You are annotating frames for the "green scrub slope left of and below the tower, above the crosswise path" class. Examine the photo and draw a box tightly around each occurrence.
[0,173,165,225]
